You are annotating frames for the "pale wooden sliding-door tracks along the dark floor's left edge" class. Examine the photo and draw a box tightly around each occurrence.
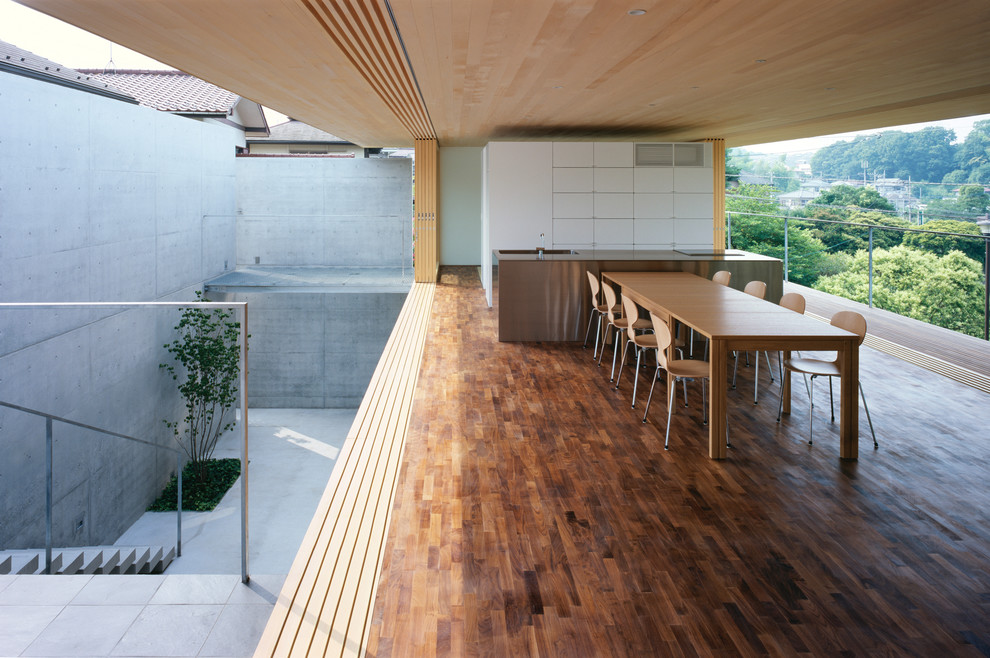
[254,283,436,656]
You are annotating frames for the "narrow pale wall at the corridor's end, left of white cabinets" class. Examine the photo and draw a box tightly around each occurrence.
[439,147,483,265]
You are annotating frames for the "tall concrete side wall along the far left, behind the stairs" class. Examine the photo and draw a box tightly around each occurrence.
[0,73,239,548]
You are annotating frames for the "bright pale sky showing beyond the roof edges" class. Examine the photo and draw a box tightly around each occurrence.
[0,0,990,149]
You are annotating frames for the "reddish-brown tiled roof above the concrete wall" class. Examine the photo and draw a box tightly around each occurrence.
[81,69,239,114]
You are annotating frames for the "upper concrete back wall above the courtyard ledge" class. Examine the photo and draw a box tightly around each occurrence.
[237,158,412,267]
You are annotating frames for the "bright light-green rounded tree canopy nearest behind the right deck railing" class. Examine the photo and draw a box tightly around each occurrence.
[815,245,983,336]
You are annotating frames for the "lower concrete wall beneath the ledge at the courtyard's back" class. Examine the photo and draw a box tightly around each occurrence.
[210,291,408,409]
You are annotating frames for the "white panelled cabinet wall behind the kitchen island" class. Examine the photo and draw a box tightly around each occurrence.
[488,142,714,249]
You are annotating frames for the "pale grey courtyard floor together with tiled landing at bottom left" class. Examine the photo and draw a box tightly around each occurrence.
[0,409,356,657]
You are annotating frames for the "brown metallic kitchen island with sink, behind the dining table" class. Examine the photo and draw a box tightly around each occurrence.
[492,249,784,342]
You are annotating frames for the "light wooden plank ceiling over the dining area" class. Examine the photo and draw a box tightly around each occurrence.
[18,0,990,146]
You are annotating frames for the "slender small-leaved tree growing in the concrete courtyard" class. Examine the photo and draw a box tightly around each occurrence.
[159,292,241,480]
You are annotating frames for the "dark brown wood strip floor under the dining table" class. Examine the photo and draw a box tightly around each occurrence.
[368,269,990,656]
